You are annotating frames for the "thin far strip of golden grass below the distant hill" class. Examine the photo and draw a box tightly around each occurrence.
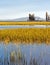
[0,21,50,25]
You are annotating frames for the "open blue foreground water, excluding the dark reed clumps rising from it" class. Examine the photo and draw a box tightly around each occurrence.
[0,42,50,65]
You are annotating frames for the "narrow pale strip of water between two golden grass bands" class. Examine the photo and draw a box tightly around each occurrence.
[0,25,50,29]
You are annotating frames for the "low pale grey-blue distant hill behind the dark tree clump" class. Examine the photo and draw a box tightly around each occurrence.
[0,17,45,21]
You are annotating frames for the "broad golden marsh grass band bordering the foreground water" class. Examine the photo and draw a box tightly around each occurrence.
[0,28,50,44]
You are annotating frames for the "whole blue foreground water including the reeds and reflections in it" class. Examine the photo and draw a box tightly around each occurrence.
[0,42,50,65]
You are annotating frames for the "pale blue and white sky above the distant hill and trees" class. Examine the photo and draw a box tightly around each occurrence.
[0,0,50,20]
